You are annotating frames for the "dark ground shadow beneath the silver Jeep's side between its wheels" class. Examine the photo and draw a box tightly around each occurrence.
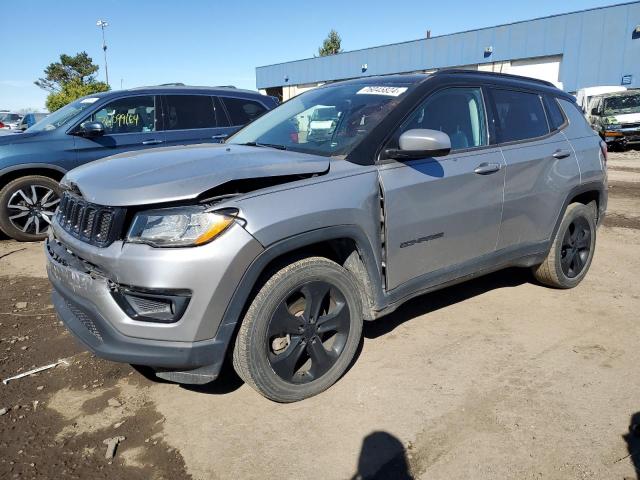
[363,268,533,339]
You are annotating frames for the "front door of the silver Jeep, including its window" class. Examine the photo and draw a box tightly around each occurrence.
[379,87,505,290]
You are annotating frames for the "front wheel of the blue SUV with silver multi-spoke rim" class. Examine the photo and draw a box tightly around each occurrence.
[0,175,60,242]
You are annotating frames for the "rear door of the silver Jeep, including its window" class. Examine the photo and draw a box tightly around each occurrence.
[489,88,580,249]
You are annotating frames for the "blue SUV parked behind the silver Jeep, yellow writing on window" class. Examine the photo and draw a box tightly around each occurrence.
[0,85,277,241]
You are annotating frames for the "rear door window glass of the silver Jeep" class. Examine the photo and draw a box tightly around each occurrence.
[492,89,549,143]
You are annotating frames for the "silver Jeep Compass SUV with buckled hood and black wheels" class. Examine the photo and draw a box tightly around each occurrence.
[45,70,607,402]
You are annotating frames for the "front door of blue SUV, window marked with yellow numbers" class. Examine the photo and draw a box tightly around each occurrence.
[74,95,163,165]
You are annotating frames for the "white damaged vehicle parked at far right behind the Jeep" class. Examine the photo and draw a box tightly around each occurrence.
[588,90,640,150]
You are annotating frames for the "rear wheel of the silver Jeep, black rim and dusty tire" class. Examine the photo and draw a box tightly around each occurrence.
[533,202,597,288]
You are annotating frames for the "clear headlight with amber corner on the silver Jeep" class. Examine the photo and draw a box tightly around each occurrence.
[127,206,238,247]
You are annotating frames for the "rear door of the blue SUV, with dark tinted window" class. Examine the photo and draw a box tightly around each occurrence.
[162,94,232,145]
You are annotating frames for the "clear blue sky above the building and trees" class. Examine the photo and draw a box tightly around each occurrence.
[0,0,632,109]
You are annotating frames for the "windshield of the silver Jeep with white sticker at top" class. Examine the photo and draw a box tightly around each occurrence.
[226,83,410,157]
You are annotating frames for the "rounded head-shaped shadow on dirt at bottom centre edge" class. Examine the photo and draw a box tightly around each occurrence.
[351,432,413,480]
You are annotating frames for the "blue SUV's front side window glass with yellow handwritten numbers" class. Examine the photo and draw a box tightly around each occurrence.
[84,95,156,135]
